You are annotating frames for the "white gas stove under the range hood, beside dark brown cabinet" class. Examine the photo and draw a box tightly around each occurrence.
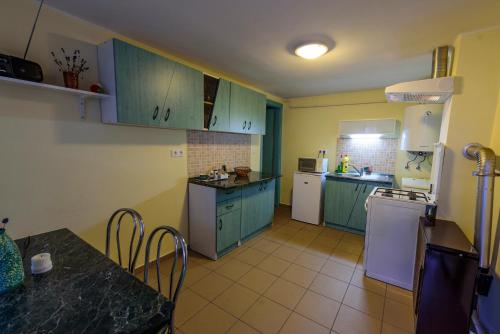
[364,187,434,290]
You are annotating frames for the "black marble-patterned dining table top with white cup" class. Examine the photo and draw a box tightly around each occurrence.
[0,229,171,334]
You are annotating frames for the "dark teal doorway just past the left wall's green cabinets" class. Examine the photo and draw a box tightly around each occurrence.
[261,100,283,207]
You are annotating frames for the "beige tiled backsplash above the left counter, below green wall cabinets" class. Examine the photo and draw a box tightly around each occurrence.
[187,131,251,177]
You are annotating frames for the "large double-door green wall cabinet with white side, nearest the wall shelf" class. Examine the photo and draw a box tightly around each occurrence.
[98,39,203,129]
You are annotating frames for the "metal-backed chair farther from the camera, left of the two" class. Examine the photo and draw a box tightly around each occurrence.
[106,208,144,274]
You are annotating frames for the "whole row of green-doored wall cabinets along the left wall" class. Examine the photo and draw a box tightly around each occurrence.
[98,39,266,134]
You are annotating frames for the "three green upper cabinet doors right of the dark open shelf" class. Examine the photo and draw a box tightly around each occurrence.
[209,79,266,135]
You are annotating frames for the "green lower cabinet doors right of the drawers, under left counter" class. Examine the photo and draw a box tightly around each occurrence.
[241,180,275,239]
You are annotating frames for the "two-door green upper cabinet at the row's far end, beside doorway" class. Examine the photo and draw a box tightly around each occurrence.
[229,82,266,135]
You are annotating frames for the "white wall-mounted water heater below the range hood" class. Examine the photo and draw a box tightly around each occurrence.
[401,104,443,152]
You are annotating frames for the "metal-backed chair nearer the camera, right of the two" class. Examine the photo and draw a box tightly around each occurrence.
[144,225,188,334]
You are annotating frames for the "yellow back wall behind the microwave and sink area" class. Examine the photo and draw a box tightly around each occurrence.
[281,89,430,204]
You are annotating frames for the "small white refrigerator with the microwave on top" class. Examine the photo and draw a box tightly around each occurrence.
[292,172,325,225]
